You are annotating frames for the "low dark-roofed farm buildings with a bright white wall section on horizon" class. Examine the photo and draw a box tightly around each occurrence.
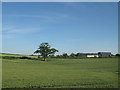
[76,52,112,58]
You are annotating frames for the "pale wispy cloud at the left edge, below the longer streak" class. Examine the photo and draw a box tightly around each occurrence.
[2,26,44,39]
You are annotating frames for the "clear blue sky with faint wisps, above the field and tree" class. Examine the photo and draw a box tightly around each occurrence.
[2,2,118,54]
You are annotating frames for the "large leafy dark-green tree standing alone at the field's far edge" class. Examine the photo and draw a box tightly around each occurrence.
[34,43,58,61]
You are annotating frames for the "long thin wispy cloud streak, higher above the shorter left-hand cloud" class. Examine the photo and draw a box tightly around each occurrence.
[3,12,74,22]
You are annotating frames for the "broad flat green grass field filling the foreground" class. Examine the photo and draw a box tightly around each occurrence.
[2,55,118,88]
